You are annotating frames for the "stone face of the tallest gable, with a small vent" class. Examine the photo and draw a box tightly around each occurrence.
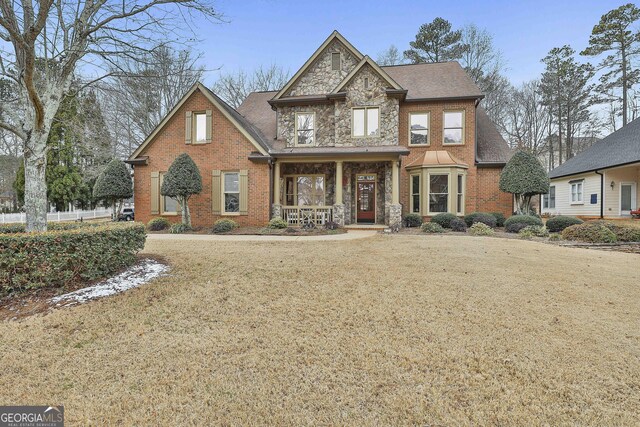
[285,40,360,96]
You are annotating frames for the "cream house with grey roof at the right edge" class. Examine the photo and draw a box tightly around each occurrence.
[541,119,640,218]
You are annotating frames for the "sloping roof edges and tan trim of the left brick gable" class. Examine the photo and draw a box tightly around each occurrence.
[127,82,269,162]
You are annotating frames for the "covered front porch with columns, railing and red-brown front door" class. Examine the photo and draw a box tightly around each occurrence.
[272,155,402,227]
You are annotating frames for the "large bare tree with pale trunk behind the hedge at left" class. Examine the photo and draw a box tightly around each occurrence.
[0,0,220,231]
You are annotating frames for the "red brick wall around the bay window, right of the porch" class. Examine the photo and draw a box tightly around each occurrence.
[399,100,512,216]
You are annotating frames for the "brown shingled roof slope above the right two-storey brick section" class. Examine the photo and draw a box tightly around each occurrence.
[380,61,484,101]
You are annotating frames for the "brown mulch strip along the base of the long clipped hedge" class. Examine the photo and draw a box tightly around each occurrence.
[0,255,167,321]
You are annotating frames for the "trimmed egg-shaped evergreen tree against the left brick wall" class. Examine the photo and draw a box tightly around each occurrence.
[160,153,202,227]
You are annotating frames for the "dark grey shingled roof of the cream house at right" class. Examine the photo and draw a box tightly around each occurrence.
[549,119,640,178]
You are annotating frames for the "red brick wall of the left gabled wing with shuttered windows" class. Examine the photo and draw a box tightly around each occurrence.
[134,91,270,227]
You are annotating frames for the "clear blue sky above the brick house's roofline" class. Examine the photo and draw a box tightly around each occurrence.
[198,0,624,85]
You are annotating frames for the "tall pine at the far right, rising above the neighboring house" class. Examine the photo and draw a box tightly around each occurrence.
[580,3,640,126]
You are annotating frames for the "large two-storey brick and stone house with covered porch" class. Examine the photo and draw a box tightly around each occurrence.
[128,32,513,226]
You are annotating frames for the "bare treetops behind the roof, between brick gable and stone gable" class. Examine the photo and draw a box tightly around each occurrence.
[213,64,290,108]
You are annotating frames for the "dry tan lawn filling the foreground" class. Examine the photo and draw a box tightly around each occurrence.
[0,236,640,425]
